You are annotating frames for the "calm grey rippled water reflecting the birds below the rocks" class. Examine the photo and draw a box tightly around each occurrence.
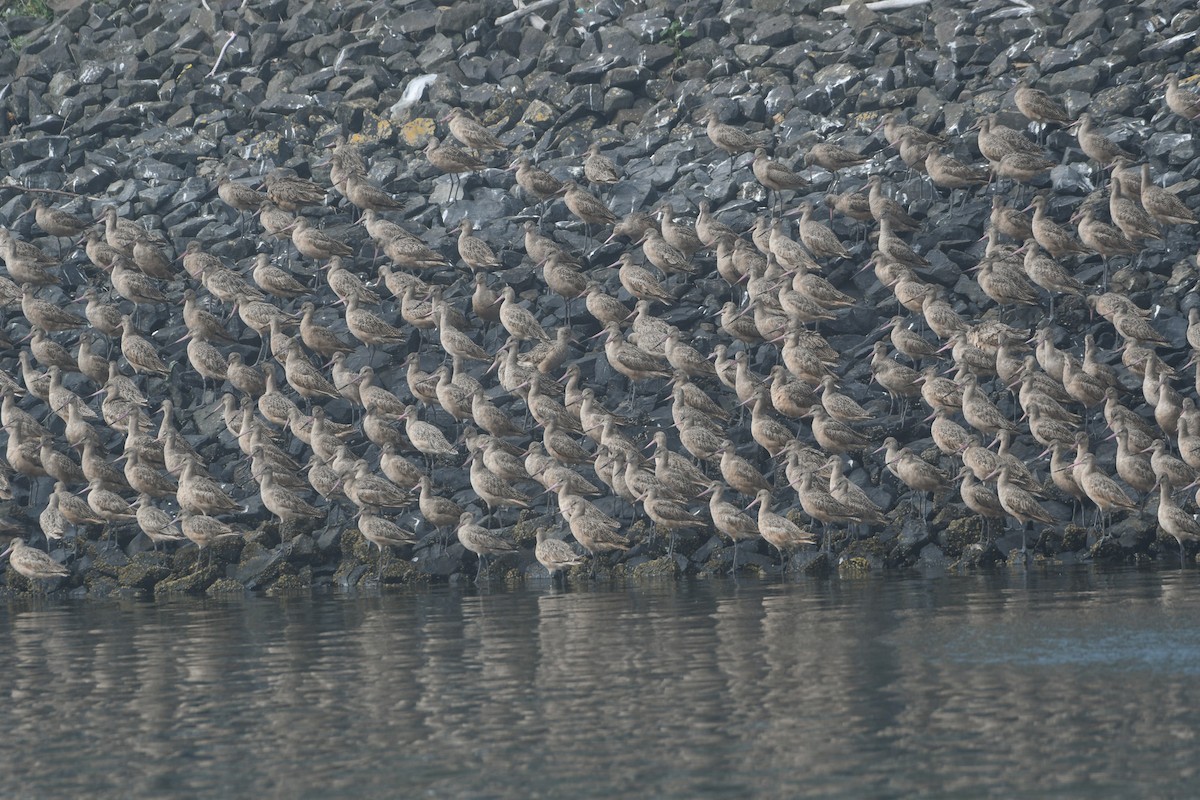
[0,569,1200,798]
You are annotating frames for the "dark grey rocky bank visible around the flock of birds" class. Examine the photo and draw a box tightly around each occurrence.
[0,0,1200,596]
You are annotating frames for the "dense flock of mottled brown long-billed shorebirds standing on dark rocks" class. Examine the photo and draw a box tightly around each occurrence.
[0,71,1200,587]
